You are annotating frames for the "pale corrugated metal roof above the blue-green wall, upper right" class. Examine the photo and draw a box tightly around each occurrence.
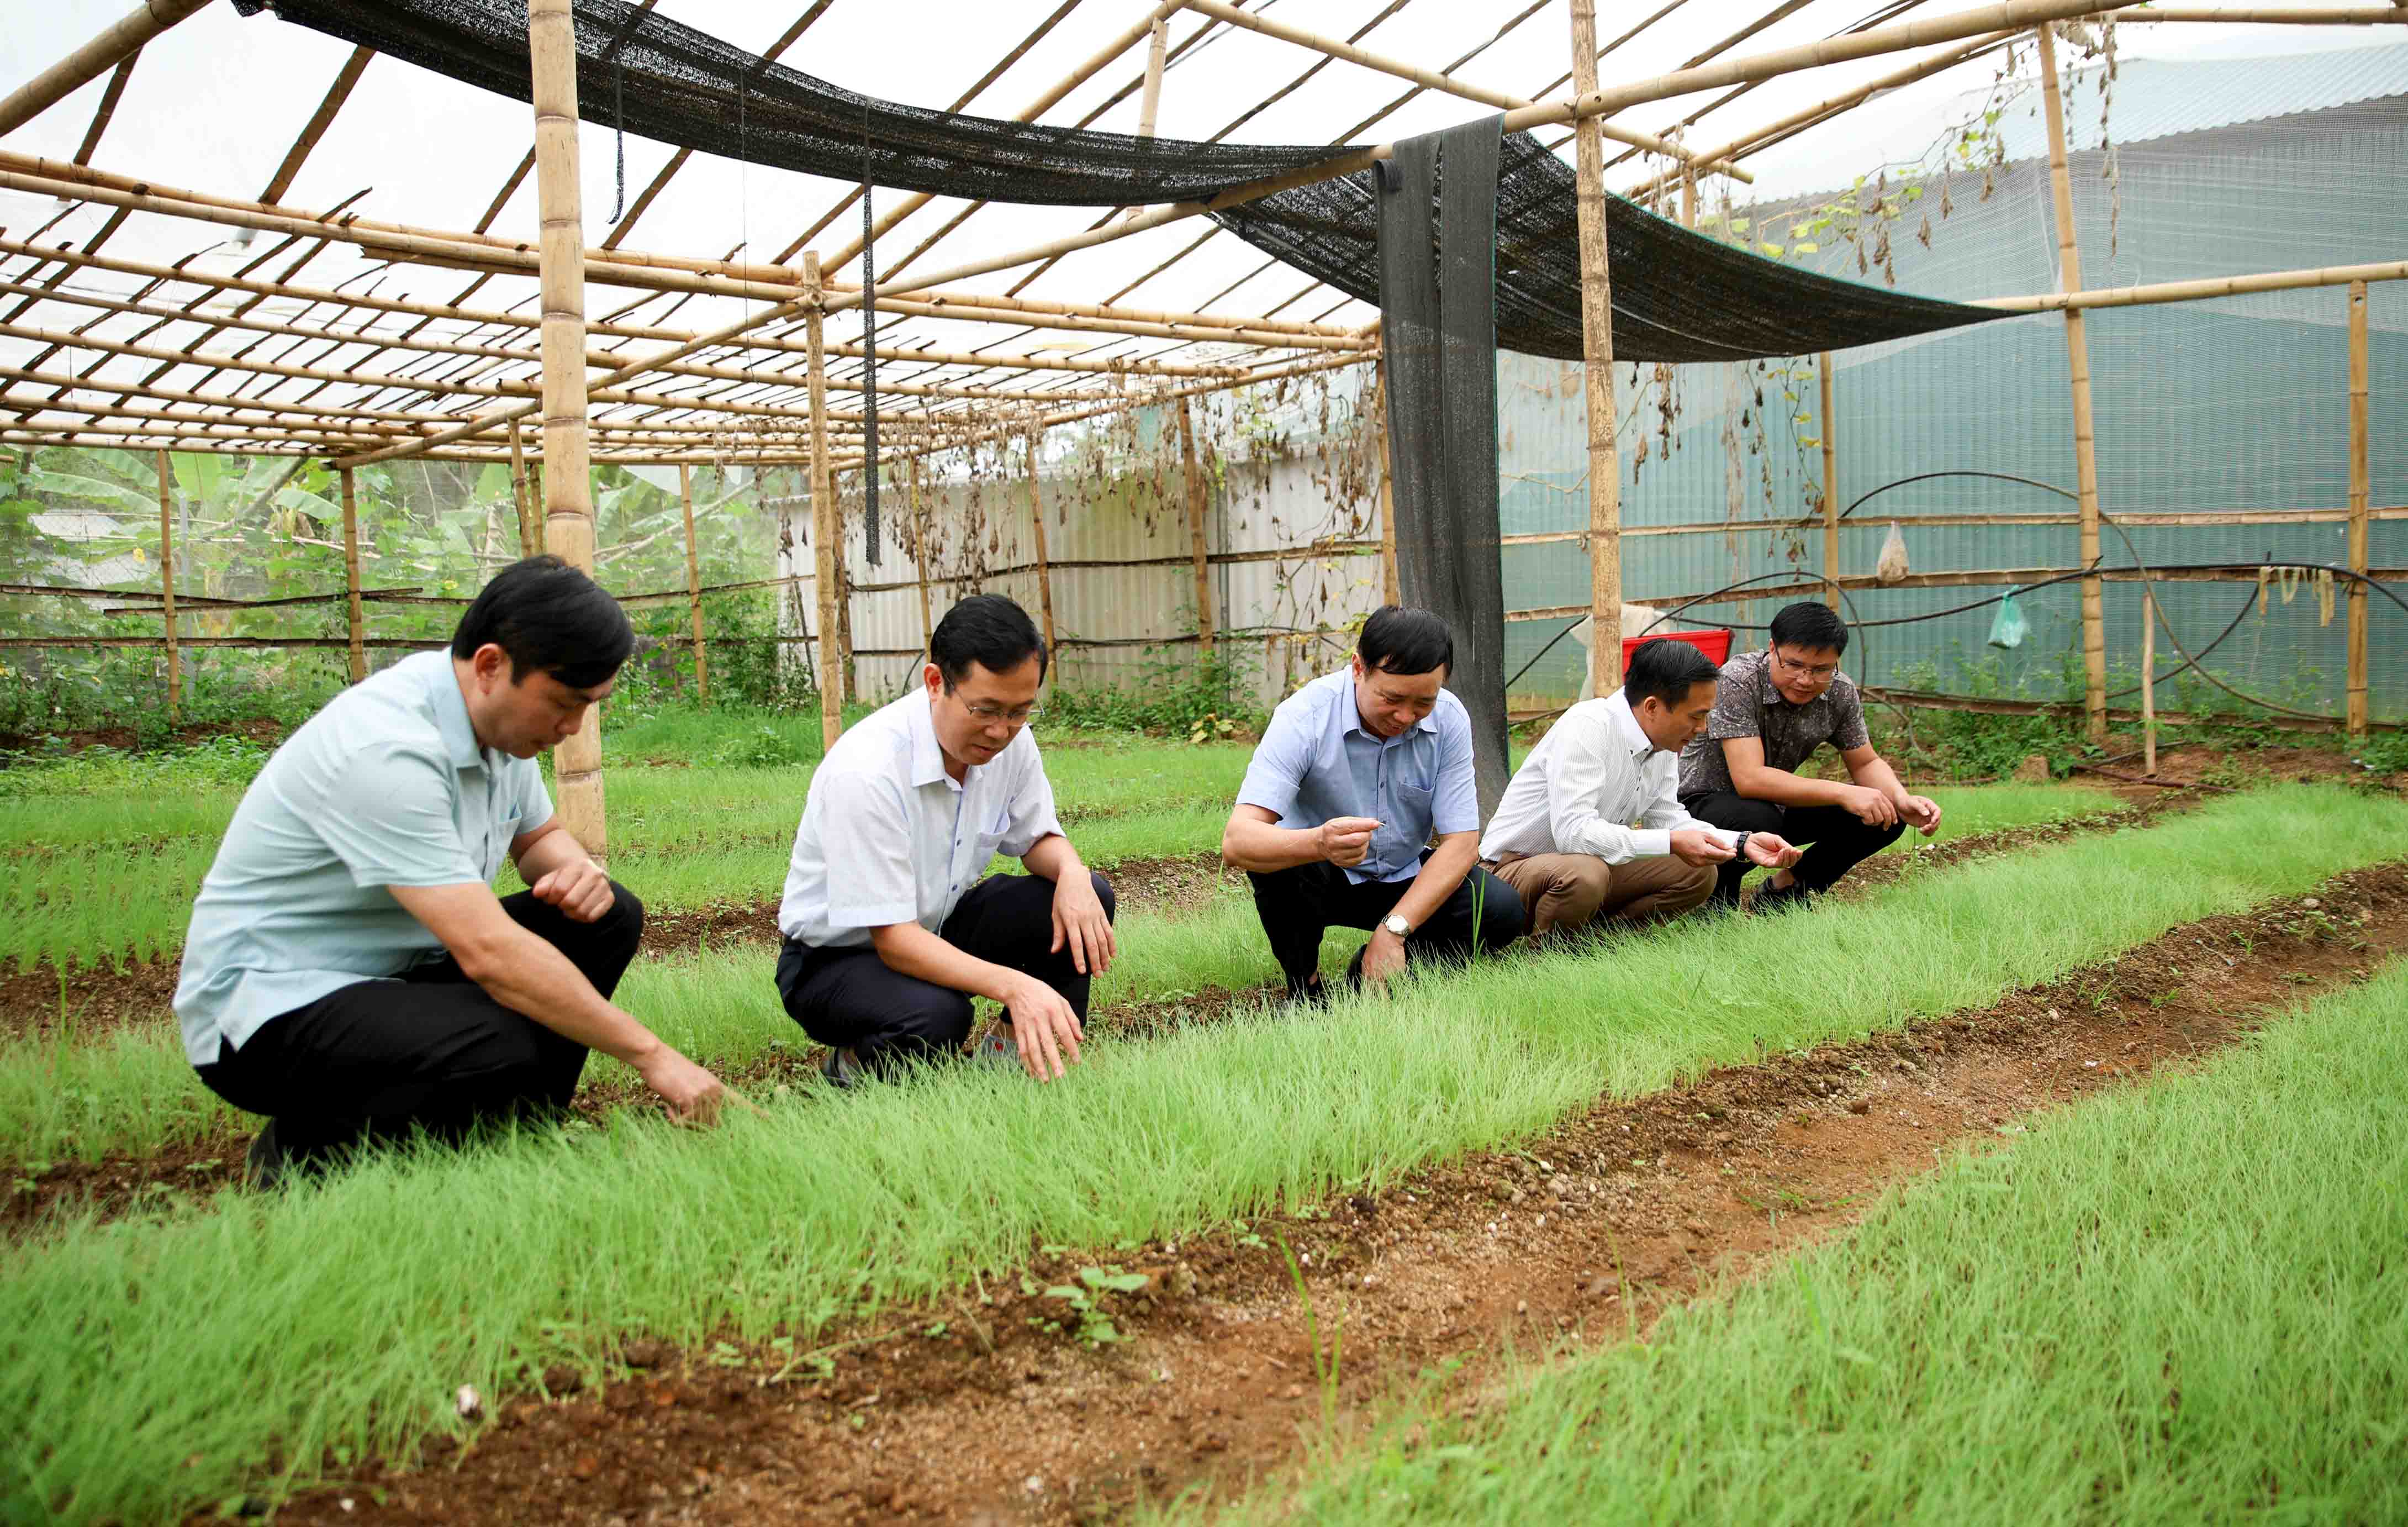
[1751,43,2408,200]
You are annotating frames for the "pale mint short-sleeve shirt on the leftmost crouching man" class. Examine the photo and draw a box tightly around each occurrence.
[176,652,551,1065]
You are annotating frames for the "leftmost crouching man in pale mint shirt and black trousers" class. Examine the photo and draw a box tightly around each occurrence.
[176,556,722,1185]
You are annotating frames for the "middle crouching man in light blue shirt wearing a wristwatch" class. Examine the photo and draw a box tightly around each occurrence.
[1221,604,1524,1002]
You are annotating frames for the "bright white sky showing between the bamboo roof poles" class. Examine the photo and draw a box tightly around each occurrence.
[0,0,2403,429]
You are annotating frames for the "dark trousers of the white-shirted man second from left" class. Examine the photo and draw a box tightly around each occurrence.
[778,870,1117,1074]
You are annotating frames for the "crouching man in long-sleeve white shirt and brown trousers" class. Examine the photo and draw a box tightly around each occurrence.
[1481,641,1799,942]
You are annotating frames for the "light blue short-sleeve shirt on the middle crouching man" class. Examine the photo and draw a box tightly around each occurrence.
[1238,667,1481,884]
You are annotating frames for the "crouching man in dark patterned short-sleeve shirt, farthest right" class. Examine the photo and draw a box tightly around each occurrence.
[1681,604,1941,910]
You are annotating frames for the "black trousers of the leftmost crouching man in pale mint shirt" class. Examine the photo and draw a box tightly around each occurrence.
[195,882,643,1161]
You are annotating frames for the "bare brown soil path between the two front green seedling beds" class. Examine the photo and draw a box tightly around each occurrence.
[263,862,2408,1522]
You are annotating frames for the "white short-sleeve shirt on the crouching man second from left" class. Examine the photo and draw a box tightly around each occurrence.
[778,686,1062,949]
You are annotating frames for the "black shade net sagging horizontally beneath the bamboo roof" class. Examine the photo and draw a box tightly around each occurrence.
[236,0,2004,361]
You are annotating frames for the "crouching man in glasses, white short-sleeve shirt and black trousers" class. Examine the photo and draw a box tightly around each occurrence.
[778,595,1115,1086]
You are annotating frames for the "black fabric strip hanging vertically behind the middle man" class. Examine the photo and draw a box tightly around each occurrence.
[1380,118,1507,819]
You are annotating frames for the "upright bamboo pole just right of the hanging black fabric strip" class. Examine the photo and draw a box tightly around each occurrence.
[1572,0,1623,694]
